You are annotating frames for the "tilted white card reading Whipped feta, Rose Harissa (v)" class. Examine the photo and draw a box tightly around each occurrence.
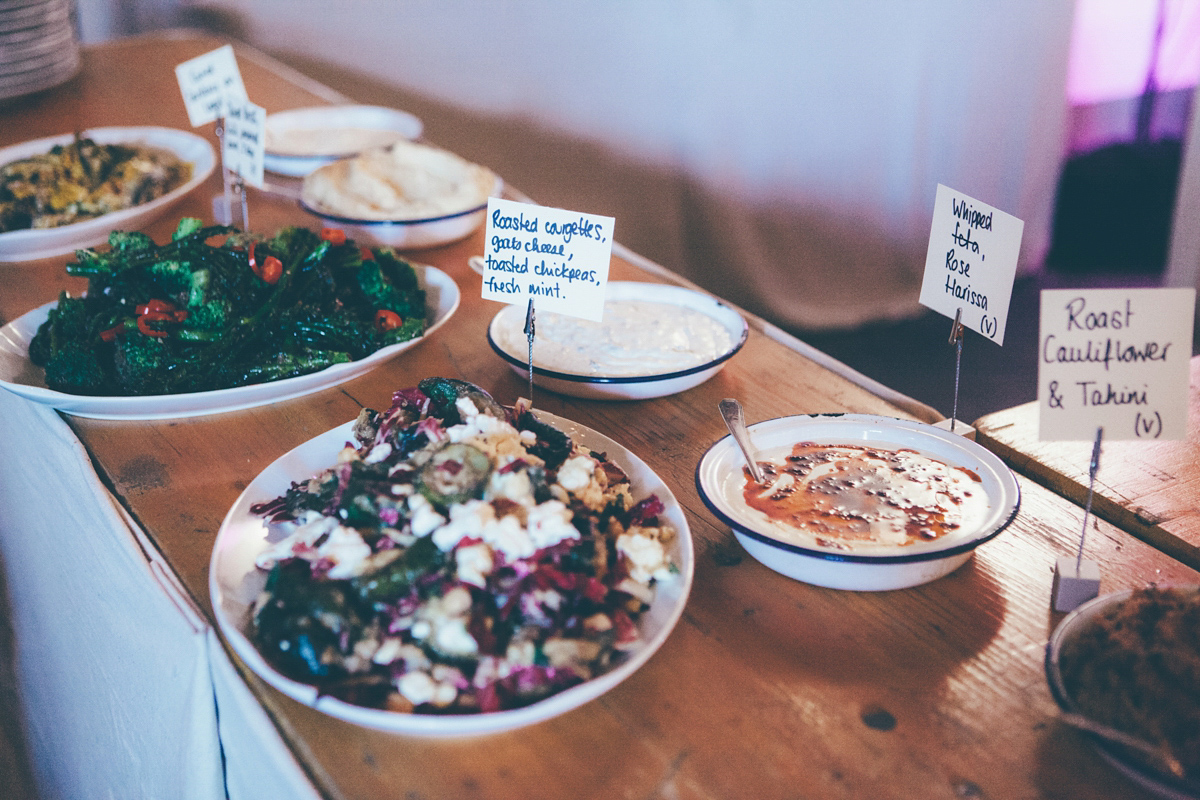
[919,184,1025,344]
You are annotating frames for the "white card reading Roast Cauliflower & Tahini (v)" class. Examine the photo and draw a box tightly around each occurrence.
[1038,289,1195,441]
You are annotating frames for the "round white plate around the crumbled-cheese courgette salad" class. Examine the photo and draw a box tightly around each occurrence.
[209,411,695,736]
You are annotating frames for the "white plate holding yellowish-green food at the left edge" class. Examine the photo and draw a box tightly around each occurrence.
[0,127,216,261]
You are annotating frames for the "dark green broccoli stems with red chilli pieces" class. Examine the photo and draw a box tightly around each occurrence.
[29,218,426,396]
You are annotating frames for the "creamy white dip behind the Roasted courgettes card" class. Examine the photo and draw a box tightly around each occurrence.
[497,300,734,378]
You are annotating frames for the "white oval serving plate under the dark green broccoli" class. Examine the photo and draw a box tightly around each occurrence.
[0,266,461,420]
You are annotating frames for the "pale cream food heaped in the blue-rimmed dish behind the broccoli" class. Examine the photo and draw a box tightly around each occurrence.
[301,140,496,221]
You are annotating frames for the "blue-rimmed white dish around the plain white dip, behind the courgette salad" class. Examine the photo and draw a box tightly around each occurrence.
[487,281,750,407]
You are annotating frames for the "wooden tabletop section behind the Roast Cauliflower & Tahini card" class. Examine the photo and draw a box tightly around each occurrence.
[976,356,1200,569]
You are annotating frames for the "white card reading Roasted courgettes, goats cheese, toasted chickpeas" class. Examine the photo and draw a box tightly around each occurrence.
[482,197,614,323]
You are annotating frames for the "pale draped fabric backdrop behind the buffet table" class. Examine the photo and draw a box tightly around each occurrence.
[110,0,1073,327]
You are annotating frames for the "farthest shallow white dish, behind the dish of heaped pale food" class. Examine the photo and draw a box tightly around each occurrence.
[263,106,424,176]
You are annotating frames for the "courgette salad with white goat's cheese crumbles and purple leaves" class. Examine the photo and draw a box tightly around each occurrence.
[251,378,677,714]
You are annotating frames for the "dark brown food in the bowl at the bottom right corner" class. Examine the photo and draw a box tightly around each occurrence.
[1058,587,1200,781]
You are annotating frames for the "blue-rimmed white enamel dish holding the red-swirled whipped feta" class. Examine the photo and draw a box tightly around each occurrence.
[696,414,1021,591]
